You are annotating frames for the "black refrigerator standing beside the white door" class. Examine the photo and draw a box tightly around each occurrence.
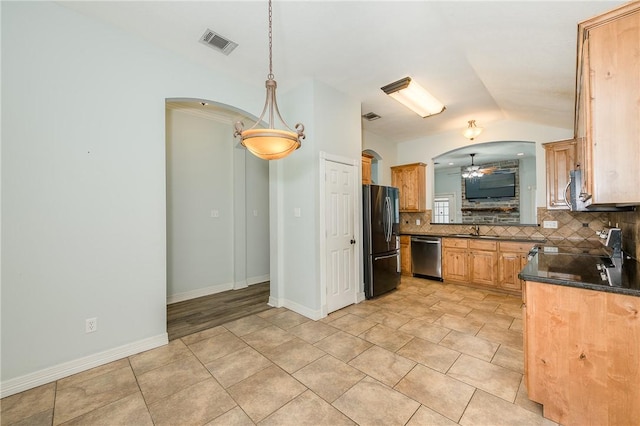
[362,185,400,299]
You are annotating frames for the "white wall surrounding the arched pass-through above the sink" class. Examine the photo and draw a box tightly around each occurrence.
[398,119,573,213]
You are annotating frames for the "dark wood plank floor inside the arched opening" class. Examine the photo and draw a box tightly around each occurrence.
[167,281,271,340]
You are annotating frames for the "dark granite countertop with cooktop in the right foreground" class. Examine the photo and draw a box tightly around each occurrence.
[519,241,640,297]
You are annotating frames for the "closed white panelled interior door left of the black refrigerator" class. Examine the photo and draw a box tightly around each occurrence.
[325,161,358,312]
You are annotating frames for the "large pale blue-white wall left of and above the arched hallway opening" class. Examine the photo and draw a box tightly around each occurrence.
[0,2,264,395]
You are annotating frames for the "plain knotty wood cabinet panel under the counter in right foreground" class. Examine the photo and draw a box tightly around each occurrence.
[523,281,640,425]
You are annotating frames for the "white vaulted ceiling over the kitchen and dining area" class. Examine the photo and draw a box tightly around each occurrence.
[59,0,624,142]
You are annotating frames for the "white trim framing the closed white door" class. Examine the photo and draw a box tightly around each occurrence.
[318,151,365,318]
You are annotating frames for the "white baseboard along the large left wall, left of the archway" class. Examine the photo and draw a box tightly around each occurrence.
[0,333,169,398]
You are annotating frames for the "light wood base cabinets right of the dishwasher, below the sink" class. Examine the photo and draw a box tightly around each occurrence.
[442,238,533,294]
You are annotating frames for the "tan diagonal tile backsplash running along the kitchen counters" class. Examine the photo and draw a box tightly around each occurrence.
[400,207,616,243]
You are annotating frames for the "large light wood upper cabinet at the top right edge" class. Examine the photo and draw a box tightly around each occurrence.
[576,2,640,205]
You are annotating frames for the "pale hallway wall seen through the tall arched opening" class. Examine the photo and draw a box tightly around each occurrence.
[167,109,269,303]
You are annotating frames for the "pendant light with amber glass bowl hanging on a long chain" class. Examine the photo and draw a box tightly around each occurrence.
[233,0,305,160]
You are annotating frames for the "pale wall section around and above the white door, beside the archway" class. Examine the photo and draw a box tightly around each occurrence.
[270,81,362,318]
